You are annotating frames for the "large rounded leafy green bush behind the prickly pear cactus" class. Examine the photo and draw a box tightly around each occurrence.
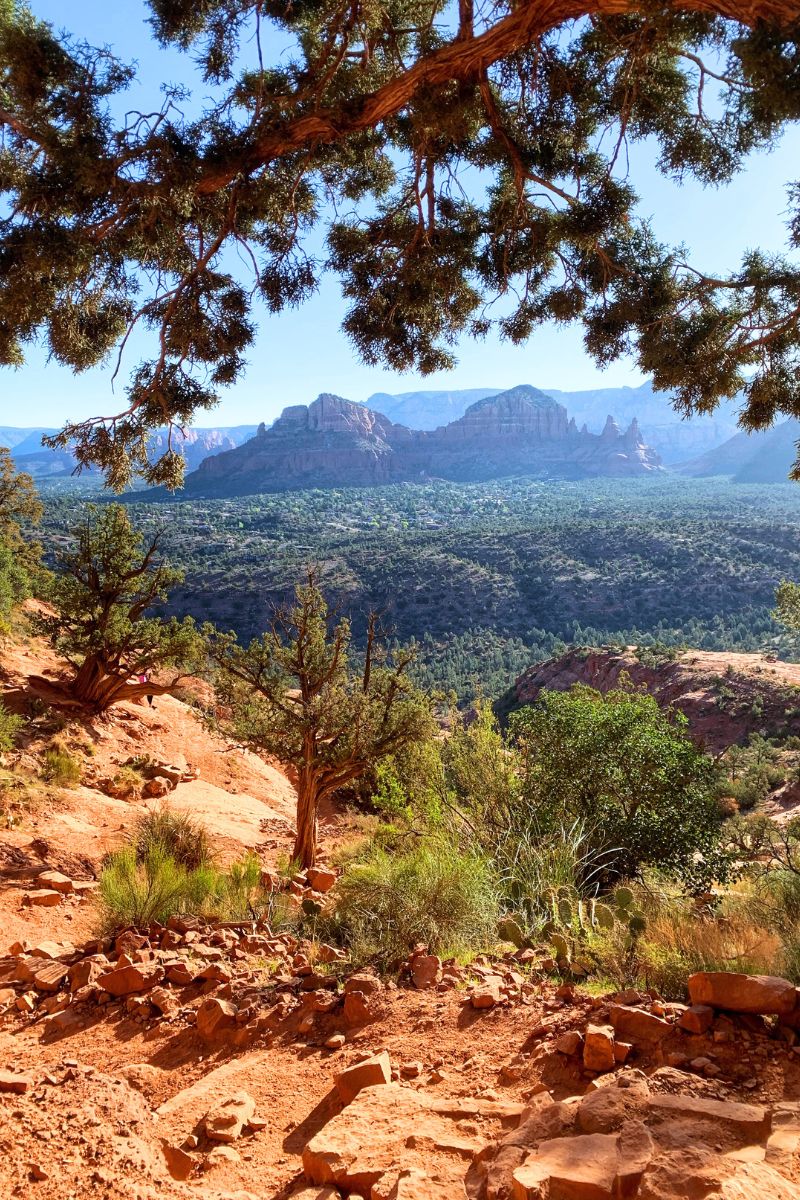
[511,686,726,889]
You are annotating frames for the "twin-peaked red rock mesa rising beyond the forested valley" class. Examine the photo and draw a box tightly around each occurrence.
[186,384,662,496]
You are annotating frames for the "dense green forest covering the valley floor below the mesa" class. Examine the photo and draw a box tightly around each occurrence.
[38,476,800,700]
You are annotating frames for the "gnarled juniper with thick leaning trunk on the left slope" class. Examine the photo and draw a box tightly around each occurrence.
[36,504,200,712]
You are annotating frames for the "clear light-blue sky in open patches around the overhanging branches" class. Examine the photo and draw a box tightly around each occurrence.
[6,0,800,426]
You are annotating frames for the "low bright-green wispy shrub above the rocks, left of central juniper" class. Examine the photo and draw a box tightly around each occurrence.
[100,842,224,929]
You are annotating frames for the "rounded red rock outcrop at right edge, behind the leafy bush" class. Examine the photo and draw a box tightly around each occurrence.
[499,647,800,751]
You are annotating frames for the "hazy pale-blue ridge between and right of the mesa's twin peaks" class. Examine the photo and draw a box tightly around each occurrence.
[366,379,738,463]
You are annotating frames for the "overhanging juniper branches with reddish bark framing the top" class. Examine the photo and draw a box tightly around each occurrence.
[0,0,800,486]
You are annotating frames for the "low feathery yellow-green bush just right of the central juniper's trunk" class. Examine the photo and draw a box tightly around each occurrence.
[331,840,498,966]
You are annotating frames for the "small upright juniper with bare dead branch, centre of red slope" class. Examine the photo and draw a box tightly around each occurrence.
[210,571,433,866]
